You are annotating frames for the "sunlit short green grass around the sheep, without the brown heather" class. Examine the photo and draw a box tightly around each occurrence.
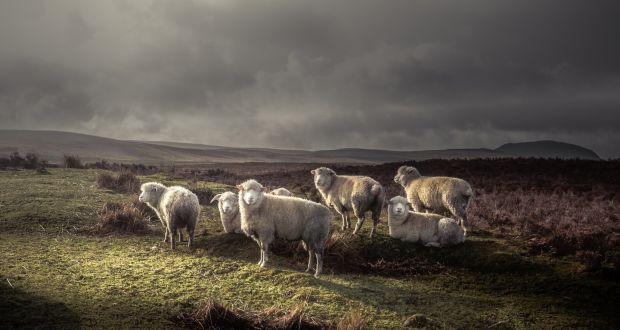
[0,169,620,329]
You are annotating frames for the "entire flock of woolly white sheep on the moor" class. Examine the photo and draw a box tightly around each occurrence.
[139,166,473,276]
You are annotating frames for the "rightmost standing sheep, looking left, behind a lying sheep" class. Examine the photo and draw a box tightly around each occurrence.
[394,166,474,234]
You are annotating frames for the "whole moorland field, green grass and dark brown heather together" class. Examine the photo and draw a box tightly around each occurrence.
[0,160,620,329]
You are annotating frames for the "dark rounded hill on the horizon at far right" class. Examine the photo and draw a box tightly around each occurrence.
[495,140,600,160]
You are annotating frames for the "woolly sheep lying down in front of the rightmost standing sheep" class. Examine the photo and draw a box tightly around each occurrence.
[388,196,465,247]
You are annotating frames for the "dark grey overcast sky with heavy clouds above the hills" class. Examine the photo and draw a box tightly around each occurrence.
[0,0,620,158]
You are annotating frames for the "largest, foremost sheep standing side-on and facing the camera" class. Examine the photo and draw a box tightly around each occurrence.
[237,180,332,277]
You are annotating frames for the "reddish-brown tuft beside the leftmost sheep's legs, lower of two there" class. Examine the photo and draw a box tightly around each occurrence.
[85,202,149,235]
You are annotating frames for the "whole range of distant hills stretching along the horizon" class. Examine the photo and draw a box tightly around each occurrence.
[0,130,599,164]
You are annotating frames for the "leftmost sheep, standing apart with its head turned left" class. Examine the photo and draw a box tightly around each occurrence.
[138,182,200,250]
